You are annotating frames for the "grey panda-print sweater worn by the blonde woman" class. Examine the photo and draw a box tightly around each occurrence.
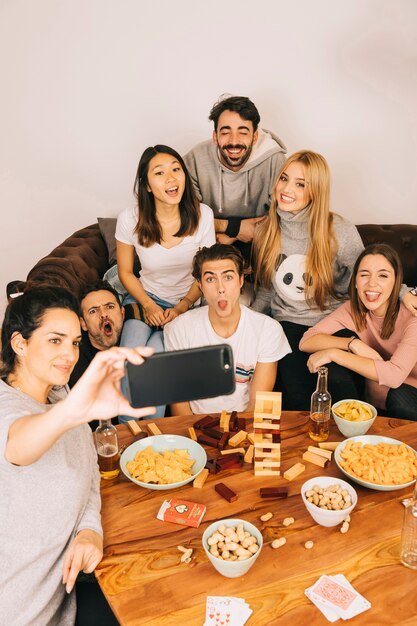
[252,208,363,326]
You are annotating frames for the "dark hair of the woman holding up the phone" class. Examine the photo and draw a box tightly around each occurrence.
[0,287,80,377]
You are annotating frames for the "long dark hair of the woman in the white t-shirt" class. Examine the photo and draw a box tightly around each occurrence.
[133,144,200,248]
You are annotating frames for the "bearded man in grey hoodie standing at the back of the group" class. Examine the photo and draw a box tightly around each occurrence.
[184,96,287,246]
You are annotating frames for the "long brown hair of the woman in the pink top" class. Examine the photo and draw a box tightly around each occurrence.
[349,243,403,339]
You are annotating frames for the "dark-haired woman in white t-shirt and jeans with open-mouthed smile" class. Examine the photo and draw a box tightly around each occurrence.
[116,145,215,351]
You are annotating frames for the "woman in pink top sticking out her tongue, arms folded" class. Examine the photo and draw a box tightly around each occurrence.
[300,244,417,421]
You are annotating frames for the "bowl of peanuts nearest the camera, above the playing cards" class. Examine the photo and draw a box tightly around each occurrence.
[202,519,263,578]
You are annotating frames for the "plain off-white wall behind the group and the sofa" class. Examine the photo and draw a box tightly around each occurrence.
[0,0,417,312]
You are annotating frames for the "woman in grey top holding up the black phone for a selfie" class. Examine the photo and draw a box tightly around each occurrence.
[0,288,152,626]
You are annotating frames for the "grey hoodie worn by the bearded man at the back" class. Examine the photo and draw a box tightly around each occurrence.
[184,129,287,218]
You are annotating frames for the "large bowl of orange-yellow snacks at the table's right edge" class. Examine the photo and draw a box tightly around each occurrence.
[334,435,417,491]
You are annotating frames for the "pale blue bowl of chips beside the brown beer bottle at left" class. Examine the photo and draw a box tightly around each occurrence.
[120,435,207,490]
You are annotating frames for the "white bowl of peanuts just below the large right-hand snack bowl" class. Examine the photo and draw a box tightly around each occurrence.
[301,476,358,526]
